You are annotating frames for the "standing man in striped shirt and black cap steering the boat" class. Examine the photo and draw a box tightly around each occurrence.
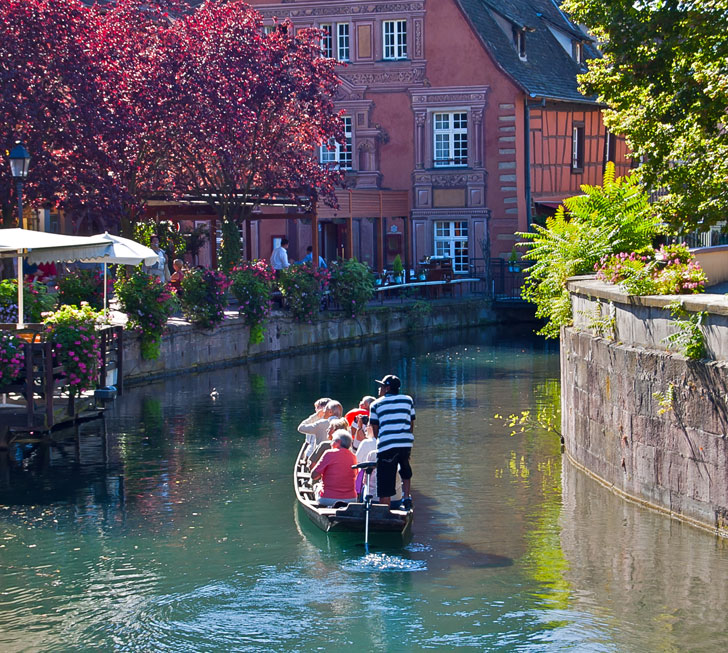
[369,374,415,509]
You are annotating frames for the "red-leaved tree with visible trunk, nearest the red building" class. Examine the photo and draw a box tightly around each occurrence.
[166,0,341,270]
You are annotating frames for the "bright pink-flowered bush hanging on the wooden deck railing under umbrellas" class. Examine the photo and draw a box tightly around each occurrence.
[43,302,103,397]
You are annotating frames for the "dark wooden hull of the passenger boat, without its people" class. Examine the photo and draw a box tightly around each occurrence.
[293,443,414,533]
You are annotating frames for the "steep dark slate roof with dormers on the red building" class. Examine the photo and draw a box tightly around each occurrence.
[455,0,599,102]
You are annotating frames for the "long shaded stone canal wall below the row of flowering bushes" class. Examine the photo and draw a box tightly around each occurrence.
[124,300,498,384]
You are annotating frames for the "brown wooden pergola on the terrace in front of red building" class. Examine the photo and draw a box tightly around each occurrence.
[147,189,411,270]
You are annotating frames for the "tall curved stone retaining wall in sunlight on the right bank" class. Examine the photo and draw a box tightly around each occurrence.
[561,279,728,536]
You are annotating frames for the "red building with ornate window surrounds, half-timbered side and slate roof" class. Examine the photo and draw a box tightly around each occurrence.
[242,0,629,274]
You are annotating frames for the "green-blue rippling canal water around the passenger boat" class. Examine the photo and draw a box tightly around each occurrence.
[0,329,728,652]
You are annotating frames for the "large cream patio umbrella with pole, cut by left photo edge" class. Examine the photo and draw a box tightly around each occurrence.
[0,229,110,329]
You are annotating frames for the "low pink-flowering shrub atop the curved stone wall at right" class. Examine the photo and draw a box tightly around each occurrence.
[595,244,707,295]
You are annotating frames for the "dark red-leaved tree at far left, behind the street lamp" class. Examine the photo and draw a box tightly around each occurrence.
[0,0,124,239]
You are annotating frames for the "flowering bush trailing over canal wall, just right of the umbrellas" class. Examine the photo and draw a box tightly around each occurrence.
[114,268,177,359]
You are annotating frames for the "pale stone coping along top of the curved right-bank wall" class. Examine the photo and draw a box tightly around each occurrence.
[566,275,728,316]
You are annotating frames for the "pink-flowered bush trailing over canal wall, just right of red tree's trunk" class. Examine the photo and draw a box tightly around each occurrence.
[230,261,275,344]
